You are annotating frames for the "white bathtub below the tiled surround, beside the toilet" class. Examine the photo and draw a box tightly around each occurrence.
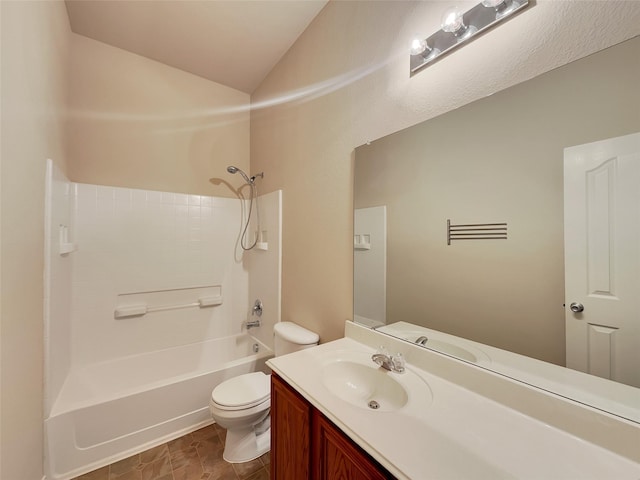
[44,335,273,480]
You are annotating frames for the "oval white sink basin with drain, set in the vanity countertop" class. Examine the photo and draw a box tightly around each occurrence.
[322,360,409,411]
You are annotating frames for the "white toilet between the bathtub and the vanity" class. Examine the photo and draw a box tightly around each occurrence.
[209,322,319,463]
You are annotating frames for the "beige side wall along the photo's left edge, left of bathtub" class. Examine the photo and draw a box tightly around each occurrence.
[0,1,70,480]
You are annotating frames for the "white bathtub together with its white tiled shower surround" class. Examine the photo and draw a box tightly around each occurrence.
[44,164,281,480]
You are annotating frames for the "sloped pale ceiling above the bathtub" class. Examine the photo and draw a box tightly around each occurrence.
[65,0,328,93]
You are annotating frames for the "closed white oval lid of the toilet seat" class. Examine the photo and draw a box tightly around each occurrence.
[211,372,271,408]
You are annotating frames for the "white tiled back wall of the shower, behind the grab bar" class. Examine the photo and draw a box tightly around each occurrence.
[69,184,249,367]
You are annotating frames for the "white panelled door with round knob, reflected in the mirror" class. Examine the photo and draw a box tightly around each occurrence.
[564,133,640,387]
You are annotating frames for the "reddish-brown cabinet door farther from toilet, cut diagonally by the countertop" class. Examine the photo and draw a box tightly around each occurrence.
[312,409,394,480]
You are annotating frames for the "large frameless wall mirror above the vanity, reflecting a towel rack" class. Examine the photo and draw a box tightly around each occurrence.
[354,37,640,422]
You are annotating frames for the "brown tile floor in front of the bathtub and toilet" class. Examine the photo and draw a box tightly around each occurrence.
[74,424,270,480]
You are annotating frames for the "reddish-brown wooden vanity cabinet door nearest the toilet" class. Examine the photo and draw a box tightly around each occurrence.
[271,374,311,480]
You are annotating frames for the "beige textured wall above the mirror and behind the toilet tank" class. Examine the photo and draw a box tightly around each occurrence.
[251,1,640,341]
